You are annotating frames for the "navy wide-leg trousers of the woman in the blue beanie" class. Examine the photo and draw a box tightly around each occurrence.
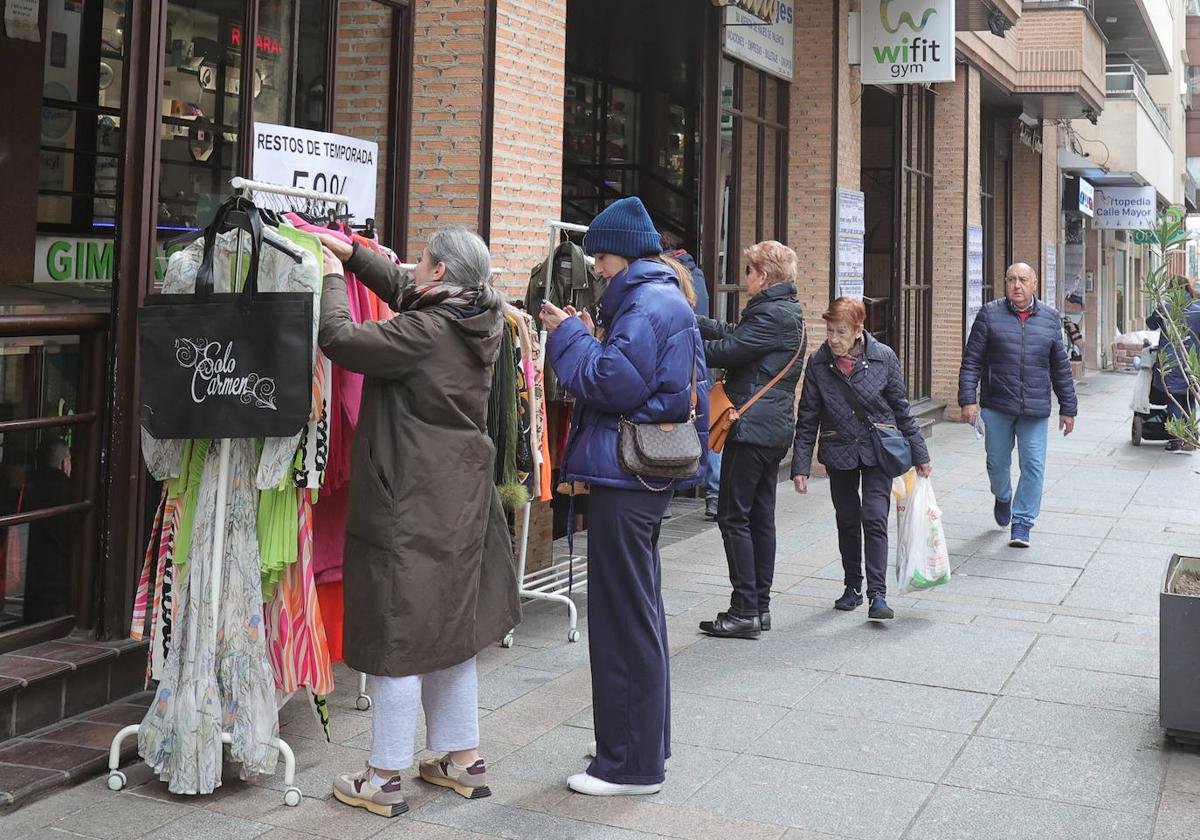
[588,485,672,785]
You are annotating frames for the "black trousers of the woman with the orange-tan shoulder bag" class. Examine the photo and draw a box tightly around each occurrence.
[716,442,787,618]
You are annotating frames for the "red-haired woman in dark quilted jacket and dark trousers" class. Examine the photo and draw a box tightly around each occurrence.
[792,298,931,620]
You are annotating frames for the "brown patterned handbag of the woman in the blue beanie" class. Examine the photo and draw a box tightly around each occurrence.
[617,333,704,493]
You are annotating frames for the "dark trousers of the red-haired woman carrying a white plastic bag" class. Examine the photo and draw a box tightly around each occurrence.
[828,466,892,596]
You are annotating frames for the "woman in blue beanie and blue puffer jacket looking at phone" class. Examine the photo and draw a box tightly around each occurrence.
[541,198,708,796]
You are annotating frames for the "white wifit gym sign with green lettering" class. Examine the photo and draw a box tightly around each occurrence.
[859,0,955,84]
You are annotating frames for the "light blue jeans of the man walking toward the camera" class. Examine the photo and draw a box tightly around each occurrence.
[980,408,1050,528]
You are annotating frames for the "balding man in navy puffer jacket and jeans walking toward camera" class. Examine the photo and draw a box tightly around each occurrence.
[959,263,1079,548]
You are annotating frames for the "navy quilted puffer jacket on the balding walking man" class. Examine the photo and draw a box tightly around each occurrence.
[959,298,1079,418]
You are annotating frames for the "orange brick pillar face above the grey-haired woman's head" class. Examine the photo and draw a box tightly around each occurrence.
[408,0,485,256]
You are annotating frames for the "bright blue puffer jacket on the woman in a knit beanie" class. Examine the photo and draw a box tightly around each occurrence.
[546,259,708,490]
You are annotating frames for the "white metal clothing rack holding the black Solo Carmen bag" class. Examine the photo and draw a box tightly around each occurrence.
[108,178,350,808]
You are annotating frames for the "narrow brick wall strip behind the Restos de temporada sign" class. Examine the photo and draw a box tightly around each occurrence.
[334,0,403,236]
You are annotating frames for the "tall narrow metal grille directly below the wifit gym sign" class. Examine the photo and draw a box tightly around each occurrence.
[893,85,935,401]
